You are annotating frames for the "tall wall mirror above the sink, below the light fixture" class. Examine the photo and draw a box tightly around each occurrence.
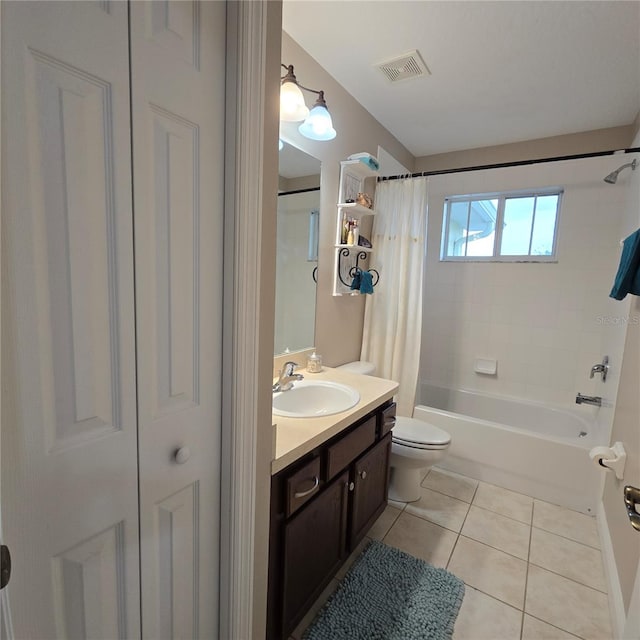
[274,142,320,355]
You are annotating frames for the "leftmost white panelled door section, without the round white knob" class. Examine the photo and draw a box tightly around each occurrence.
[1,0,140,639]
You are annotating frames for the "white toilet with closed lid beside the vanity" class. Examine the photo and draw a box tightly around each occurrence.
[338,361,451,502]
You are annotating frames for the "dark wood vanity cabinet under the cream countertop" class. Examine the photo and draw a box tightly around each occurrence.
[267,401,395,640]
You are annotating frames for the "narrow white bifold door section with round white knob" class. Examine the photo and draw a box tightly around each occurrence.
[131,0,225,639]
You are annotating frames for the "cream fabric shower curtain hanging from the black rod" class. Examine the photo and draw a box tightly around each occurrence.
[361,178,428,417]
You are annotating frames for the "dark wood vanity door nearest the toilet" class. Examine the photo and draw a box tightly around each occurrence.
[349,434,391,549]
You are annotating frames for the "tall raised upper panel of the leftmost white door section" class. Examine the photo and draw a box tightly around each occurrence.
[26,51,120,451]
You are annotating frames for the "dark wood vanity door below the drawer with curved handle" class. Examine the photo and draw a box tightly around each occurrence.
[282,471,348,637]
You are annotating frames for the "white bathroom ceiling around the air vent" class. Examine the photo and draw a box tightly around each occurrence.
[283,0,640,157]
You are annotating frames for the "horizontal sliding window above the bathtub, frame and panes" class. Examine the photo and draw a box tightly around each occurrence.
[441,189,562,262]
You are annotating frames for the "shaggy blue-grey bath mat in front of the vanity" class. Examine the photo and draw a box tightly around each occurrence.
[303,541,464,640]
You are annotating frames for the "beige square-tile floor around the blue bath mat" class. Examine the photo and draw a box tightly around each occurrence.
[292,469,611,640]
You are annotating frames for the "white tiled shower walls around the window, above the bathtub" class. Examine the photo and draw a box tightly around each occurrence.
[418,156,635,414]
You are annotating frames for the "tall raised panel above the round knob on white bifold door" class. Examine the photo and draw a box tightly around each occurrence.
[148,106,200,418]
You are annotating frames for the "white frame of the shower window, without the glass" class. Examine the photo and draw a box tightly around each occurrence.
[440,187,564,262]
